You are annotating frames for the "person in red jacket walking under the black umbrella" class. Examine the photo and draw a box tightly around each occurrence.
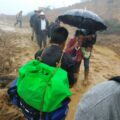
[65,30,86,88]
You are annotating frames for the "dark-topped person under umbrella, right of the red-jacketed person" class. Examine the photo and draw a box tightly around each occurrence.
[81,30,97,85]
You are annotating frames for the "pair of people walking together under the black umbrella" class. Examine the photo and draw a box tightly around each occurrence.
[65,29,96,85]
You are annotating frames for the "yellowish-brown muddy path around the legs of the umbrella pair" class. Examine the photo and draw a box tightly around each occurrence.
[67,46,120,120]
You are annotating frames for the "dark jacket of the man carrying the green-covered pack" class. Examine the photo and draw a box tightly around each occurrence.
[35,45,76,86]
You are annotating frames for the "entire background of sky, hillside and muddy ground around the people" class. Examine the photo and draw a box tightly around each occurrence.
[0,0,120,120]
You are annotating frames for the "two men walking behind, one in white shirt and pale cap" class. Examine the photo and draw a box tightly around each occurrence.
[30,10,49,48]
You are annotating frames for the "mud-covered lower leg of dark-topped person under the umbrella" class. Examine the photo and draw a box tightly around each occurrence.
[83,58,90,85]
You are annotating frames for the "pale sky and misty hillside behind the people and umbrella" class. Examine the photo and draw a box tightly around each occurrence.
[0,0,120,34]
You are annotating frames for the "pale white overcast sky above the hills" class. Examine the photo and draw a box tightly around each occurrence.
[0,0,81,15]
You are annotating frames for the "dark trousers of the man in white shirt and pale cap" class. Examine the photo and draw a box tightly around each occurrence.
[36,31,47,48]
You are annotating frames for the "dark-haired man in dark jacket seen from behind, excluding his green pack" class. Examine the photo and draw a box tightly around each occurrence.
[35,27,76,87]
